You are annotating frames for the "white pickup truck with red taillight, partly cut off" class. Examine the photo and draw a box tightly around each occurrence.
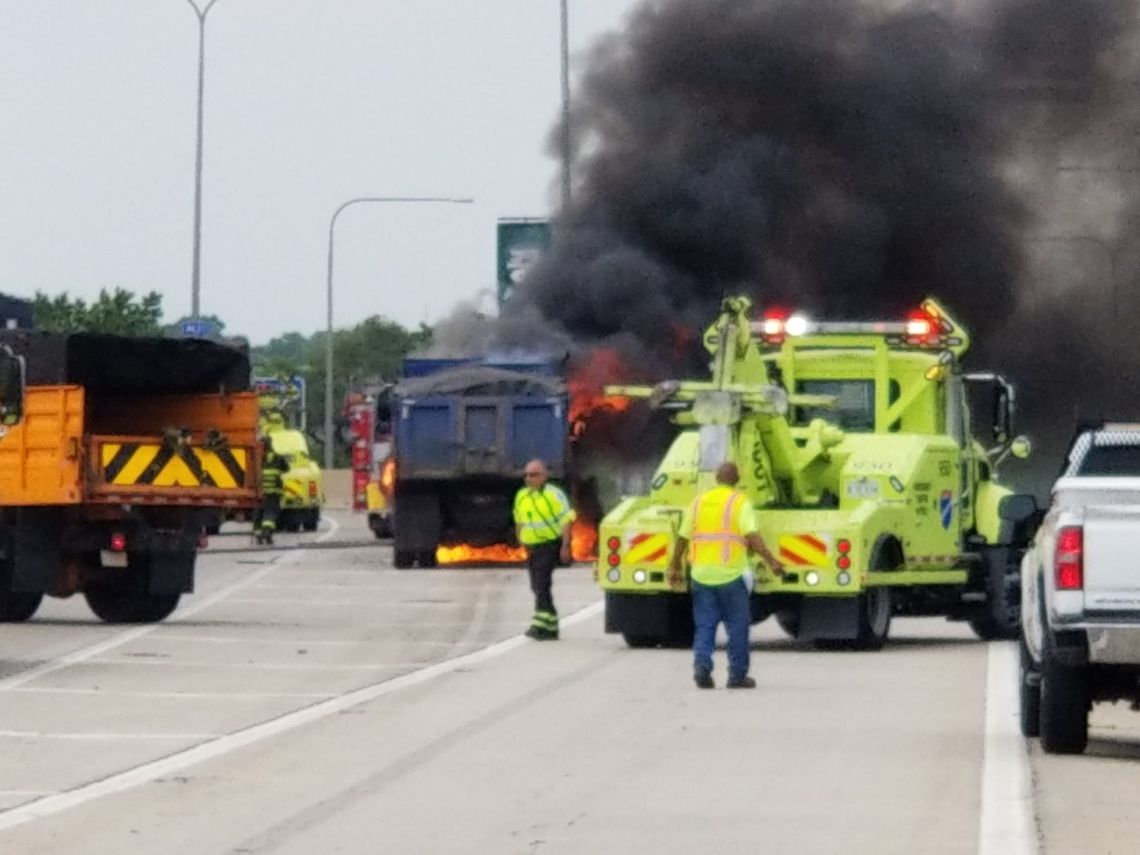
[1020,423,1140,754]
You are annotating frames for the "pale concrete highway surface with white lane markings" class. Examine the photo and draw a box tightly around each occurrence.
[0,514,1140,855]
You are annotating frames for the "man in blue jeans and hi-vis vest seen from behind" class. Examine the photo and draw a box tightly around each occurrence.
[669,463,783,689]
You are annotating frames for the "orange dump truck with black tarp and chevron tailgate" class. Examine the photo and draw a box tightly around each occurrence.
[0,331,260,622]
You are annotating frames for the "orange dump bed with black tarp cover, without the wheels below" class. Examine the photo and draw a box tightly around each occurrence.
[0,331,258,507]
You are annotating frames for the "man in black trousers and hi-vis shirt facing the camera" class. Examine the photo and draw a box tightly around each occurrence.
[514,461,575,641]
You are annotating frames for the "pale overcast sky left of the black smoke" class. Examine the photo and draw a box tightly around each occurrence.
[0,0,635,343]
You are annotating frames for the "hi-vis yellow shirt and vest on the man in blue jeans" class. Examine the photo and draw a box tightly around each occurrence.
[677,486,758,585]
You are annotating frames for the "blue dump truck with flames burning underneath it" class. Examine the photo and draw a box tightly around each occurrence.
[392,358,569,569]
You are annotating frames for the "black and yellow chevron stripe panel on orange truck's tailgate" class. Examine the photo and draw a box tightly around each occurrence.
[101,442,249,489]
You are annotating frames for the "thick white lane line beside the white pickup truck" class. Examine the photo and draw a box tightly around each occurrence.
[978,642,1037,855]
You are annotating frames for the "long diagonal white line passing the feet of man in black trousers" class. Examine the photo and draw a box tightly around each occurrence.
[0,601,603,831]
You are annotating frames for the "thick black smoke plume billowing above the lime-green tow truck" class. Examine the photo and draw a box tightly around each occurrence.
[476,0,1140,499]
